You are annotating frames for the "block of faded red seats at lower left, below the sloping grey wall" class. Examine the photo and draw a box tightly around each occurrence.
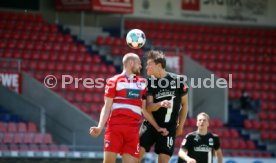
[0,106,69,152]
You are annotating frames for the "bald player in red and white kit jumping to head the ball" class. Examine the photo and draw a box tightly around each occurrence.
[90,53,168,163]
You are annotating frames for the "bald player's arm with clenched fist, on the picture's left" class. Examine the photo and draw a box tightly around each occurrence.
[90,97,113,137]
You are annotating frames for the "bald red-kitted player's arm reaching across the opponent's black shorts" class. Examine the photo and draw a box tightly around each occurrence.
[142,100,169,136]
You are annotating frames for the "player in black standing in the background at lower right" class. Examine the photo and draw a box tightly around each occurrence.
[178,112,222,163]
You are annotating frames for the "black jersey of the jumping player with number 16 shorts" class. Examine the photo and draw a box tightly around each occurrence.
[147,72,188,128]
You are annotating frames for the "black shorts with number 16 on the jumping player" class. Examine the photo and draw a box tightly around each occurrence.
[140,122,175,156]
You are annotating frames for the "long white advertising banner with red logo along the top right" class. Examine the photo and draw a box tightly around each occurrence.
[127,0,276,26]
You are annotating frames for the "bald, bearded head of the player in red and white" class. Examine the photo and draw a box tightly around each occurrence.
[123,53,142,75]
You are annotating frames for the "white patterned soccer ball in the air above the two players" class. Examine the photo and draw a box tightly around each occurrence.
[126,29,146,49]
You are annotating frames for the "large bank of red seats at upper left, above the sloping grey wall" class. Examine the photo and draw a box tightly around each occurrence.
[0,12,117,120]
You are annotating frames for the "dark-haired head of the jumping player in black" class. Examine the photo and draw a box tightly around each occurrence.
[147,50,166,76]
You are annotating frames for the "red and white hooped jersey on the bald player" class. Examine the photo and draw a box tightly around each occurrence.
[105,74,146,125]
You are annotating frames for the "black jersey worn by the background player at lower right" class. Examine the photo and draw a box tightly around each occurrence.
[178,131,220,163]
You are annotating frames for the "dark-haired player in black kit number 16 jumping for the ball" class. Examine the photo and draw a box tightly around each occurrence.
[140,51,188,163]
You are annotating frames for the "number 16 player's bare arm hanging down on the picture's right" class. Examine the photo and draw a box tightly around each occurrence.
[176,94,188,136]
